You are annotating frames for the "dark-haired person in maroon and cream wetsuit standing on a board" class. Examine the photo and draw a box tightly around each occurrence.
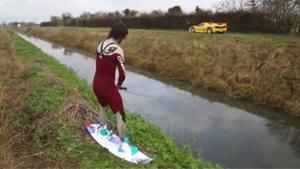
[93,22,128,140]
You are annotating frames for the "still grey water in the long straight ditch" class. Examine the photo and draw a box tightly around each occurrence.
[20,32,300,168]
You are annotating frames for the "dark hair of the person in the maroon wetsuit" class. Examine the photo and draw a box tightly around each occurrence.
[108,21,128,39]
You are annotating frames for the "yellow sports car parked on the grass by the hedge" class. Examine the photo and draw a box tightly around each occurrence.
[189,22,227,34]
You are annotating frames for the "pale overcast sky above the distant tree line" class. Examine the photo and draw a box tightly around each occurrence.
[0,0,220,23]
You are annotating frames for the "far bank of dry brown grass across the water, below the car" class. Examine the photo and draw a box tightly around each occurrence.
[15,27,300,116]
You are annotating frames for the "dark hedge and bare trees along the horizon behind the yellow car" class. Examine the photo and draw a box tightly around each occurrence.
[41,0,300,34]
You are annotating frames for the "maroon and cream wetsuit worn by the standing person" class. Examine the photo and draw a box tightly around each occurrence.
[93,39,125,121]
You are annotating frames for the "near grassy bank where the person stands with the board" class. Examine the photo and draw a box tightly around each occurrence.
[0,28,220,168]
